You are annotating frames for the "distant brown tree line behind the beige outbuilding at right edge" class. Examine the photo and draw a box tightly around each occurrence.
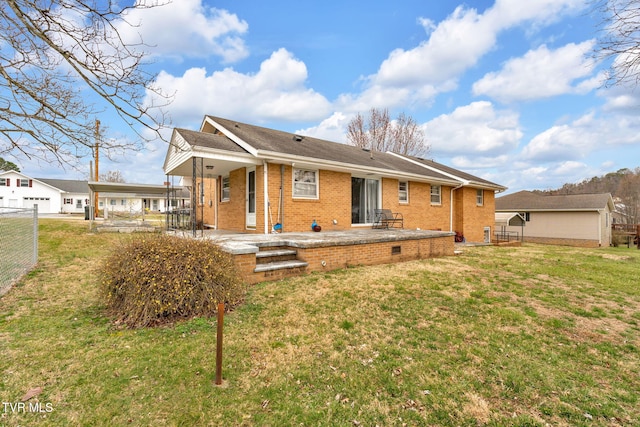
[535,167,640,224]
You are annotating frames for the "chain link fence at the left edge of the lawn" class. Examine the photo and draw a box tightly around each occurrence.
[0,206,38,295]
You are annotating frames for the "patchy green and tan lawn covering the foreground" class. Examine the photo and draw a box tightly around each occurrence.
[0,219,640,426]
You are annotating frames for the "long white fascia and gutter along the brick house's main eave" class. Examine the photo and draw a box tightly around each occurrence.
[258,150,459,185]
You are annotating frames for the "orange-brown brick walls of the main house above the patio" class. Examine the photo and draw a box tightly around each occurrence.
[212,164,495,237]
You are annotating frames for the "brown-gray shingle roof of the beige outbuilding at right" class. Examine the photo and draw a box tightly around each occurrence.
[496,191,611,212]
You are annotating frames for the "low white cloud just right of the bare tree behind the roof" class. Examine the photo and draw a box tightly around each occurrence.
[424,101,522,156]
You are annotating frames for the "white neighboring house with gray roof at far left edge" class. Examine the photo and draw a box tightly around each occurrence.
[0,171,89,213]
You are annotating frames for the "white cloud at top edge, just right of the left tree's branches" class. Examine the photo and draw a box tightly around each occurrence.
[119,0,249,63]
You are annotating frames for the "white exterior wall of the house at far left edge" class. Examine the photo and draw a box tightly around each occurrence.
[0,171,62,213]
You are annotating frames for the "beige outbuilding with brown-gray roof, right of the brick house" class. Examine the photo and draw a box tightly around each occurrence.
[496,191,615,247]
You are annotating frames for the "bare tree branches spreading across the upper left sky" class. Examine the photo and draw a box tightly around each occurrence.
[0,0,169,164]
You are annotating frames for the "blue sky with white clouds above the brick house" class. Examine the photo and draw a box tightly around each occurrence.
[20,0,640,192]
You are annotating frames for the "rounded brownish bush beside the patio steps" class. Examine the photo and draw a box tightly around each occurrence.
[98,234,246,327]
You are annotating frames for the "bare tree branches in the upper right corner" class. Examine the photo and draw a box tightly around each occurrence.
[593,0,640,86]
